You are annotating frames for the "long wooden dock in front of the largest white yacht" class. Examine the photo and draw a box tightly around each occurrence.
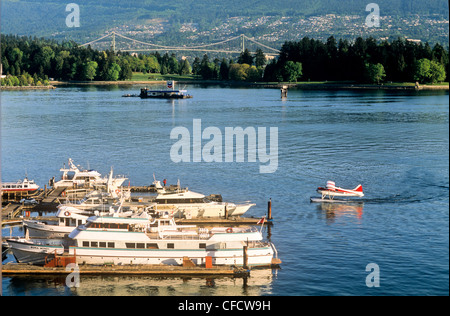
[2,263,250,277]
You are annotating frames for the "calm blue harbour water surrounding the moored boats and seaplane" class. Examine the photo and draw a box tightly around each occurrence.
[1,86,449,296]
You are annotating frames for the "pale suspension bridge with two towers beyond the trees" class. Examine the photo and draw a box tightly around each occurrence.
[80,31,280,56]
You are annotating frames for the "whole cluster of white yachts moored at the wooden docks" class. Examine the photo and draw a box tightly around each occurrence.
[2,158,281,275]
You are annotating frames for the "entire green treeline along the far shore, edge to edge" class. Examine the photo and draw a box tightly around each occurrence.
[1,35,449,85]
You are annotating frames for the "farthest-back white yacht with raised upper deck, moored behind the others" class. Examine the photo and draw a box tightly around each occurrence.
[53,158,127,188]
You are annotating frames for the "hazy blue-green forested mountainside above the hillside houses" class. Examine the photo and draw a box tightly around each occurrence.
[1,0,448,42]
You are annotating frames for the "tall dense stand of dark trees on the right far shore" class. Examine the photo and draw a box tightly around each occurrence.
[264,36,449,83]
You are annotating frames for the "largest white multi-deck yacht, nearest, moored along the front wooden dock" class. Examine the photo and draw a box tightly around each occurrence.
[8,216,276,266]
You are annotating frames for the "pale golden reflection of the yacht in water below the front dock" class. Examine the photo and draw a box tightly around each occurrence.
[48,269,276,296]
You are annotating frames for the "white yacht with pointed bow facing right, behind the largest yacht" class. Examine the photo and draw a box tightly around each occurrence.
[155,189,255,219]
